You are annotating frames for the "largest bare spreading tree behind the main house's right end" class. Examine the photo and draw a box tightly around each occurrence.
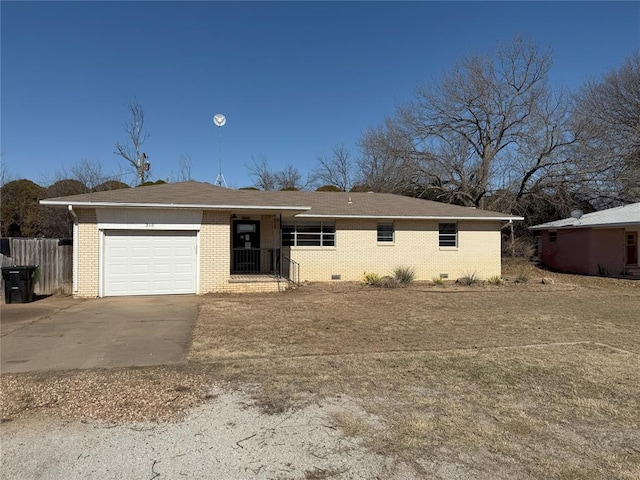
[361,39,574,206]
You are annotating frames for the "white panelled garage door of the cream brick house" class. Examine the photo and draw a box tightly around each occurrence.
[103,230,197,297]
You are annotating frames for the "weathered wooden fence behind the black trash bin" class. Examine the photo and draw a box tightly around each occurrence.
[0,238,73,295]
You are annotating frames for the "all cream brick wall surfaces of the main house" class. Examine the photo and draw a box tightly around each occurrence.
[75,209,500,297]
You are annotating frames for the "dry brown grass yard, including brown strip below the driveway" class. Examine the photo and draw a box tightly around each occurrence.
[1,265,640,479]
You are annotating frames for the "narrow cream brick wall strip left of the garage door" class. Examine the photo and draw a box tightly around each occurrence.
[74,208,100,298]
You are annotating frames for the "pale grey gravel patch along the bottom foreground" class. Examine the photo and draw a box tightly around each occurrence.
[2,390,418,480]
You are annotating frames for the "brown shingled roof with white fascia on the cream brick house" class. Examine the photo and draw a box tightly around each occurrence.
[40,181,522,220]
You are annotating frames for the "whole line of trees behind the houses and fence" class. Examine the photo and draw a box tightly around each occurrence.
[2,38,640,242]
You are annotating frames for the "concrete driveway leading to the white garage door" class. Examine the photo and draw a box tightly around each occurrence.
[0,295,200,373]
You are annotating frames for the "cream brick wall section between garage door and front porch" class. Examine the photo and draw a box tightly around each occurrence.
[198,210,231,294]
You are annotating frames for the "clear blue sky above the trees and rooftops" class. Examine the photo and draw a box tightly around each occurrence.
[0,1,640,187]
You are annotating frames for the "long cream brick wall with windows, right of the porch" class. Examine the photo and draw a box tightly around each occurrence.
[291,220,501,281]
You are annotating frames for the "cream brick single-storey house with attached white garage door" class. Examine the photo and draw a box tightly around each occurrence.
[41,182,522,297]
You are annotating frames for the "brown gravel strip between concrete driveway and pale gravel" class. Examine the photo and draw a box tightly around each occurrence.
[0,366,212,422]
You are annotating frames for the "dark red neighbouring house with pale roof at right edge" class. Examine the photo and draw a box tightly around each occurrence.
[530,203,640,279]
